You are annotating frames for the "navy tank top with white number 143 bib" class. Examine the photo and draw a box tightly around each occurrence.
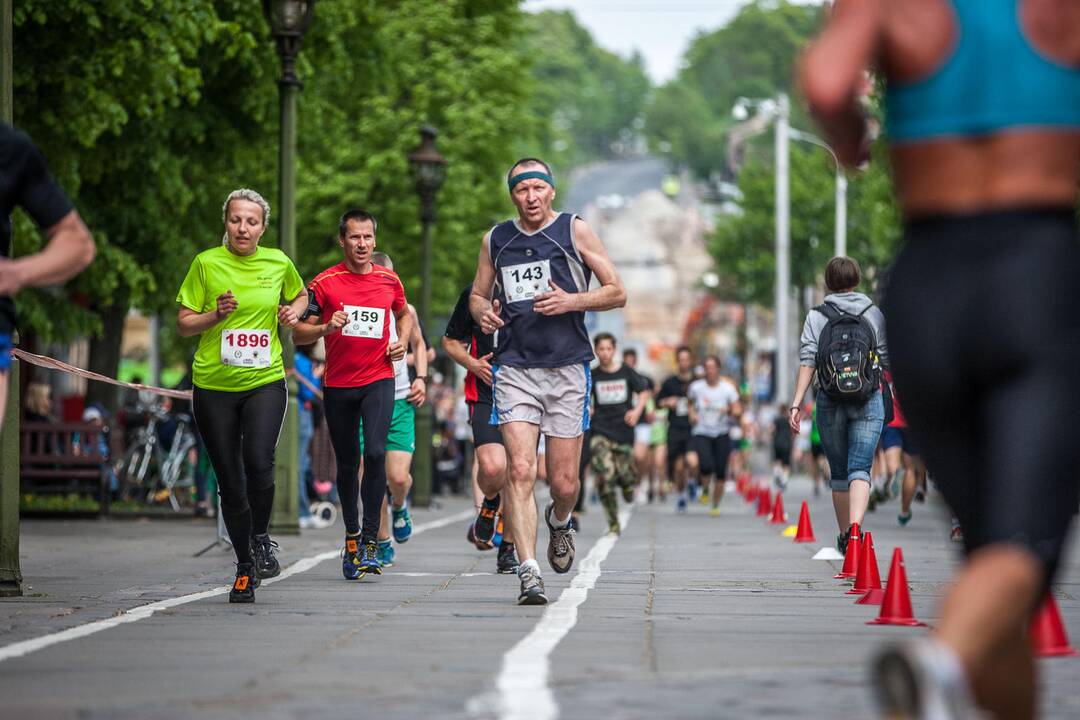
[488,213,593,368]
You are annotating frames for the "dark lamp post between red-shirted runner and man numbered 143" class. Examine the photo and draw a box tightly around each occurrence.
[408,126,446,507]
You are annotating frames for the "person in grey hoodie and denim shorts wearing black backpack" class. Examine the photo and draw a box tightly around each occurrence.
[787,257,891,553]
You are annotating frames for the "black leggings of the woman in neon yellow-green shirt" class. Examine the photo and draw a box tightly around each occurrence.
[191,380,288,562]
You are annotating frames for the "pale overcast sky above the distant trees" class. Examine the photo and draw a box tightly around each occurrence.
[524,0,820,83]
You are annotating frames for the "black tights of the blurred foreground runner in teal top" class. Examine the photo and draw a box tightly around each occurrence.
[882,209,1080,583]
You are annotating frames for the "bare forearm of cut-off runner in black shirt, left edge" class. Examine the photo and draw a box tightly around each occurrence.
[0,210,96,296]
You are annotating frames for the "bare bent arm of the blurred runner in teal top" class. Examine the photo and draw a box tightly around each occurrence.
[798,0,885,166]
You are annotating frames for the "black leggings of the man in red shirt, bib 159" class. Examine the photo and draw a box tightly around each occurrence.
[323,378,394,542]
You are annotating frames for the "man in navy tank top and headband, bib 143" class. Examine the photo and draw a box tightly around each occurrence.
[469,158,626,604]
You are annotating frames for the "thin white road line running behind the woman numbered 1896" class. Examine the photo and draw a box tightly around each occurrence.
[0,510,474,662]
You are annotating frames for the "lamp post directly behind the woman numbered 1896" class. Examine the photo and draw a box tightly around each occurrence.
[262,0,315,534]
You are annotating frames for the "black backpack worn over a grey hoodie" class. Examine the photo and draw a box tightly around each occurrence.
[814,302,881,405]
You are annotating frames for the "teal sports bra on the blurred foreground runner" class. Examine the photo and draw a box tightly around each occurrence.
[886,0,1080,142]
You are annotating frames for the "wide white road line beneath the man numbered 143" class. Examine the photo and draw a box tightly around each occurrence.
[467,505,633,720]
